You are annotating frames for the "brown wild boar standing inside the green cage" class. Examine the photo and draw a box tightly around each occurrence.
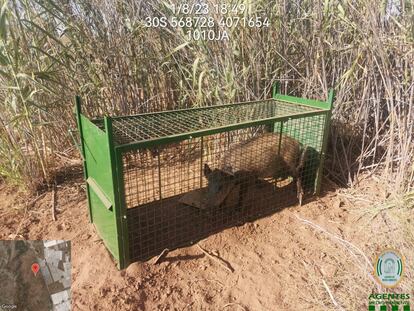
[204,133,307,210]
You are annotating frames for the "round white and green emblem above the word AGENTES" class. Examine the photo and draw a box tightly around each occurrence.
[375,249,403,287]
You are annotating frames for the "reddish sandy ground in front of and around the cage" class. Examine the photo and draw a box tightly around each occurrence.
[0,168,414,311]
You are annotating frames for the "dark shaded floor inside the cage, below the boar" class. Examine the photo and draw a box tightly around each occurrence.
[127,182,298,262]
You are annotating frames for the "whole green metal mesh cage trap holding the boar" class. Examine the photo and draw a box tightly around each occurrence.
[76,86,333,269]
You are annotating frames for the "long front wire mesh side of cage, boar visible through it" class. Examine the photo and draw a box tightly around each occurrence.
[123,115,325,261]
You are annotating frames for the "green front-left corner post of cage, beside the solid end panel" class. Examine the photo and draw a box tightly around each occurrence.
[104,116,128,269]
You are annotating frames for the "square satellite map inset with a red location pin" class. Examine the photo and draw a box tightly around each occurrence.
[0,240,71,311]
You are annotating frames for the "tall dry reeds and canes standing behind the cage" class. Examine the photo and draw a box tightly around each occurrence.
[0,0,414,192]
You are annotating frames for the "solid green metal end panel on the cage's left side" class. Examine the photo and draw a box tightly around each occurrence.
[80,115,121,262]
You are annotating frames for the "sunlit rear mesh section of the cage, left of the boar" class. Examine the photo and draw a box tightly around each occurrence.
[123,139,201,208]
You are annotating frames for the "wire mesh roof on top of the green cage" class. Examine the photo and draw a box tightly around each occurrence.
[94,99,318,145]
